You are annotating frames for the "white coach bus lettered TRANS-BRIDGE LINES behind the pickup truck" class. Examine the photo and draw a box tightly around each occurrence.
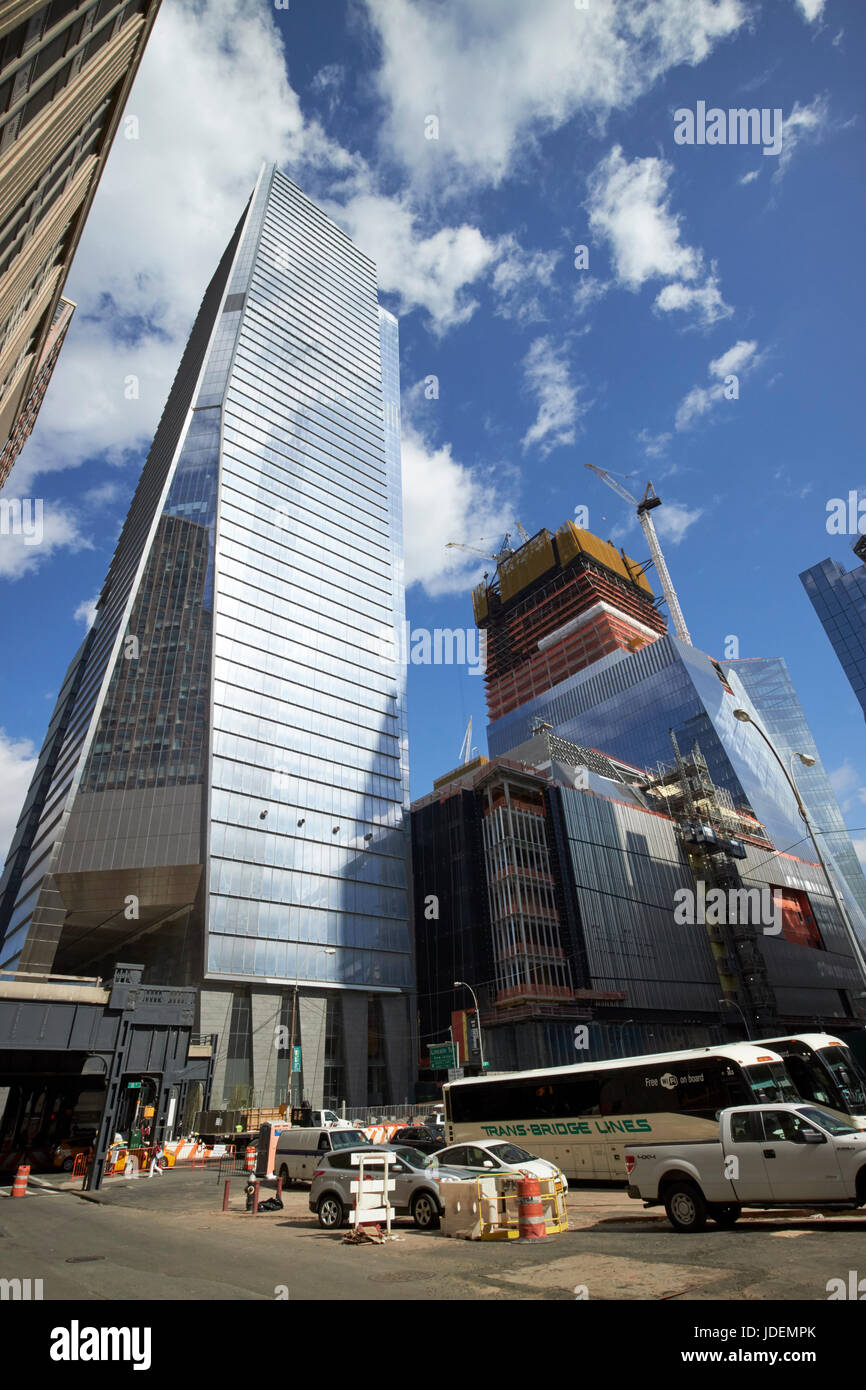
[442,1043,799,1180]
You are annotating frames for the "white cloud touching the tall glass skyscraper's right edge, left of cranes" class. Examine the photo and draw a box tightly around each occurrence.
[403,420,516,598]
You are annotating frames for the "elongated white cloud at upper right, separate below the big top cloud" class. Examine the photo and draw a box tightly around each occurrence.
[587,145,731,324]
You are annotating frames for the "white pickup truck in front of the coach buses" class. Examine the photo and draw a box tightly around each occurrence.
[626,1104,866,1232]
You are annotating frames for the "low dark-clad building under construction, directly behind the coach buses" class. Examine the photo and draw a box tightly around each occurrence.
[411,728,862,1086]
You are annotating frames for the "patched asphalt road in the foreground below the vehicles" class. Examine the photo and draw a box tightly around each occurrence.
[0,1172,866,1302]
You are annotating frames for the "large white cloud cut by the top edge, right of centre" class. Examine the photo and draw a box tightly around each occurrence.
[366,0,748,192]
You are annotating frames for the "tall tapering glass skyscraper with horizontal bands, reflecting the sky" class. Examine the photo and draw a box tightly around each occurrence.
[0,167,413,1105]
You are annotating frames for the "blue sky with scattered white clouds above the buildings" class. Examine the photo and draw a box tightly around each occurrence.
[0,0,866,852]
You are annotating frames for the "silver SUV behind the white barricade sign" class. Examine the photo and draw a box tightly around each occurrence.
[310,1144,466,1230]
